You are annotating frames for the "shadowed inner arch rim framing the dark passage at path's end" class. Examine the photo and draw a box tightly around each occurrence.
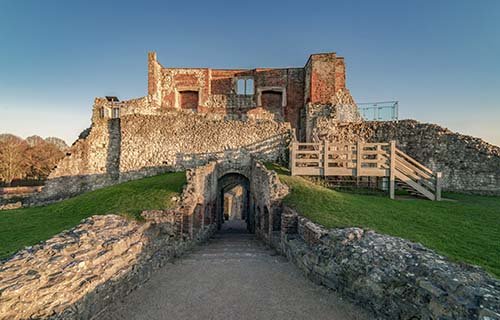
[216,172,255,233]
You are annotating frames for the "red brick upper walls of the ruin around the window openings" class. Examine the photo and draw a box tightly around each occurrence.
[148,53,345,128]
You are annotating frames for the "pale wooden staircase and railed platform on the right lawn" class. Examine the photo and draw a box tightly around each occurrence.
[290,141,442,201]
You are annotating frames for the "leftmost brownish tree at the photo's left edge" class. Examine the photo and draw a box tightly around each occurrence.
[0,135,28,185]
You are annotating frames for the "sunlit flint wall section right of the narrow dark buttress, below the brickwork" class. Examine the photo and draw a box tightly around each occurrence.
[120,113,290,173]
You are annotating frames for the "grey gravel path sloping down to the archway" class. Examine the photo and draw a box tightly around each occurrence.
[98,223,370,320]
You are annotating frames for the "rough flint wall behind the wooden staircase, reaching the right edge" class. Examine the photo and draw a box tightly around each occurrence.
[315,120,500,195]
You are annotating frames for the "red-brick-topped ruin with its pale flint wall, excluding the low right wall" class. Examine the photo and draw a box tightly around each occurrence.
[35,53,364,204]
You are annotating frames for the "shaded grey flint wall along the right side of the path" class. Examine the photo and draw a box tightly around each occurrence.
[280,207,500,320]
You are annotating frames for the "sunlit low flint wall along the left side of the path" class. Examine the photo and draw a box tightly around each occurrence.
[0,210,213,320]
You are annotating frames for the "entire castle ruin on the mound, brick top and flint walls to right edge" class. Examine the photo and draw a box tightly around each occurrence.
[38,52,500,201]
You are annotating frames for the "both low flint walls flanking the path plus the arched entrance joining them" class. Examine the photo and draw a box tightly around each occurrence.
[0,160,500,320]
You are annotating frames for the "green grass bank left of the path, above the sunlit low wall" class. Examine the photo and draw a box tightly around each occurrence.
[0,172,186,259]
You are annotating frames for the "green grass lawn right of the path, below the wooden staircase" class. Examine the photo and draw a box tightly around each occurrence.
[267,164,500,277]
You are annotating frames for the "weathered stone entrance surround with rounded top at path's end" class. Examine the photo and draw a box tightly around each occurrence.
[179,153,288,243]
